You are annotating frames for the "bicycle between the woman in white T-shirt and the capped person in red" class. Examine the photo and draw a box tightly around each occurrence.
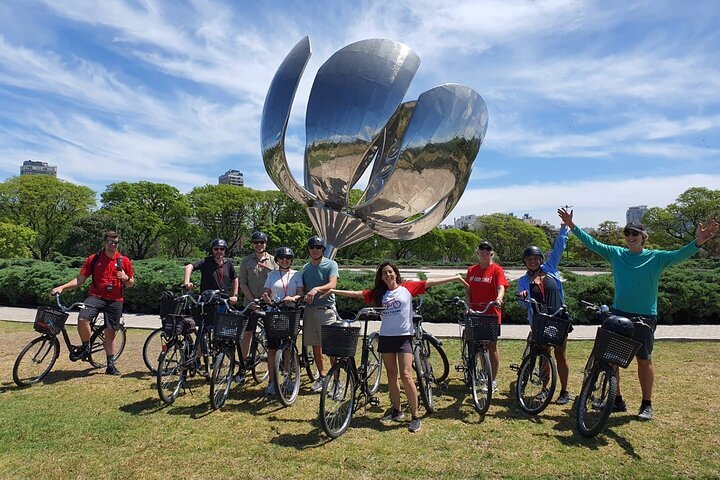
[412,298,450,413]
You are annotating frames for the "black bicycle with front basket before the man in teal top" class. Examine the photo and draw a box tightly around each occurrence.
[576,300,652,438]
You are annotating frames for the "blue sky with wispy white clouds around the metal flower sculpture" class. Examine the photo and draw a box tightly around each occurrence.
[0,0,720,230]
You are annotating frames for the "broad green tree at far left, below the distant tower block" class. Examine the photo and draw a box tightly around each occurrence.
[0,175,95,260]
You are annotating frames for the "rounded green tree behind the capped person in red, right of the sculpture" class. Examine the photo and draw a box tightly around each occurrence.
[475,213,550,261]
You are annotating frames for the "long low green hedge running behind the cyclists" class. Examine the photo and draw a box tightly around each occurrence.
[0,257,720,324]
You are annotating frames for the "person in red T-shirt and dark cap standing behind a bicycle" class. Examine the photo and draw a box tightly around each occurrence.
[465,240,510,391]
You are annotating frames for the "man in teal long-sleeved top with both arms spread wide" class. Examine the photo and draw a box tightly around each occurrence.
[558,208,718,420]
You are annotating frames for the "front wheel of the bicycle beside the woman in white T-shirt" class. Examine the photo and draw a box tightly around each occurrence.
[320,360,356,438]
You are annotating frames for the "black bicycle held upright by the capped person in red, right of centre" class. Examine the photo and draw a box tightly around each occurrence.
[446,297,500,415]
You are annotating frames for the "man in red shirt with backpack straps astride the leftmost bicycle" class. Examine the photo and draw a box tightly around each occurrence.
[52,231,135,375]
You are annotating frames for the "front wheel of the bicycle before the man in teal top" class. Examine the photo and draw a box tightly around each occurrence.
[577,365,617,438]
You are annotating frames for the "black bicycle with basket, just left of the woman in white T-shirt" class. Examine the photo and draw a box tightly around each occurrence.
[319,307,384,438]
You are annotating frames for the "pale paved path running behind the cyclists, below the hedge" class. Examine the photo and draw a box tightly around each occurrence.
[0,307,720,340]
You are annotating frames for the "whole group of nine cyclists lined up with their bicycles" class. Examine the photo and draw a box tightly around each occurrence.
[53,208,719,432]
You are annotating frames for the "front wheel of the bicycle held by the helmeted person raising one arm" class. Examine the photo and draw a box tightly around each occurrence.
[515,352,557,415]
